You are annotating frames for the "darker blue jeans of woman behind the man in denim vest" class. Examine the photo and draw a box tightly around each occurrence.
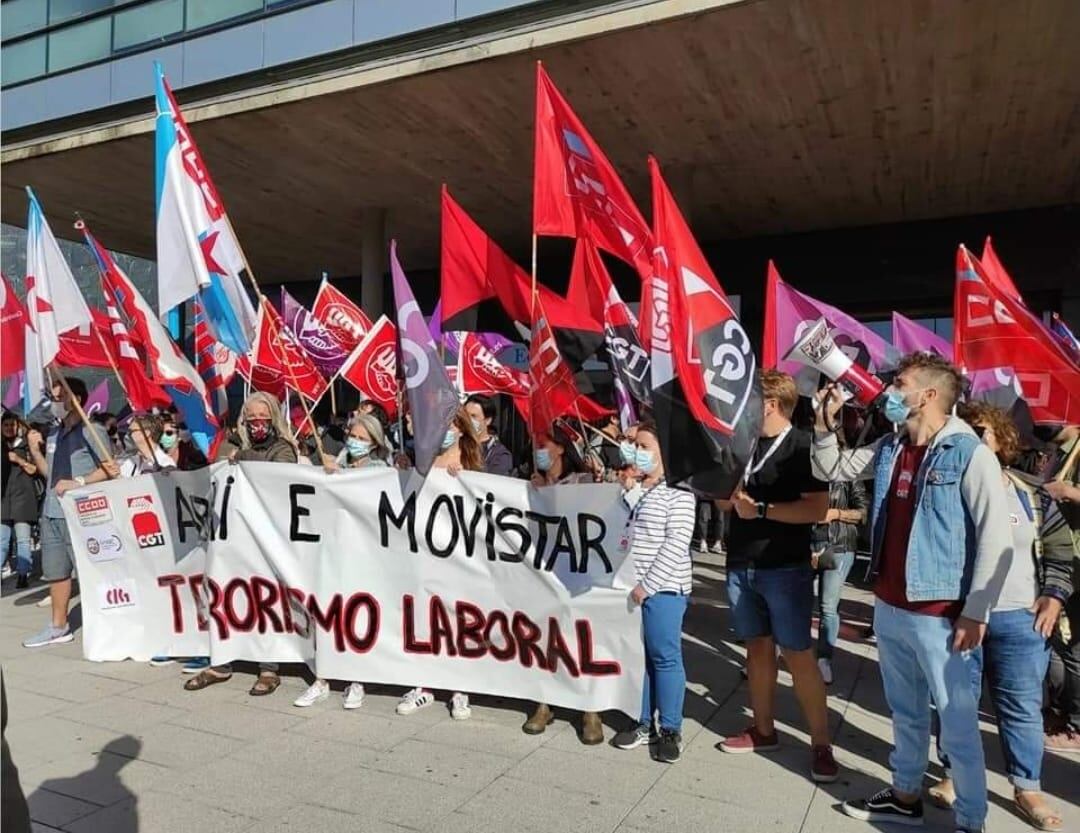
[937,609,1050,792]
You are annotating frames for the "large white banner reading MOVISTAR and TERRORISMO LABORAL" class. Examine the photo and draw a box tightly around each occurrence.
[63,463,644,715]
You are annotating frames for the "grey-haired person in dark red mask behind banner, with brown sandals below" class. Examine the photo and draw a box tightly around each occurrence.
[184,391,299,697]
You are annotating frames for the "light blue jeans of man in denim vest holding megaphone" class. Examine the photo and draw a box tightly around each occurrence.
[874,599,986,830]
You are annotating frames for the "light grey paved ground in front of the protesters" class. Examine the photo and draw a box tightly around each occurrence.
[0,557,1080,833]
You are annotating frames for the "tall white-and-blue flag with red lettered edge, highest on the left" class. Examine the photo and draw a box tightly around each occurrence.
[156,64,256,353]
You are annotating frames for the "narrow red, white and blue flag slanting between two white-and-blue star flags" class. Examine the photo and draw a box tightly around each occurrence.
[82,224,218,455]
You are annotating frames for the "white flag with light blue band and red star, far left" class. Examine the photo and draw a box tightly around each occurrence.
[23,188,93,414]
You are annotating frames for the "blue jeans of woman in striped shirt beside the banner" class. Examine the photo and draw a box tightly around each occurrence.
[642,593,689,731]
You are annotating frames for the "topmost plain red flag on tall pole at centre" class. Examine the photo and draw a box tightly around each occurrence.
[532,64,652,280]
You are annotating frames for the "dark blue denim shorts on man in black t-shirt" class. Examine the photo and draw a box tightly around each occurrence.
[728,565,814,650]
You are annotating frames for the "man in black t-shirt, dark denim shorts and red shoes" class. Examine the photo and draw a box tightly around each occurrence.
[717,371,838,782]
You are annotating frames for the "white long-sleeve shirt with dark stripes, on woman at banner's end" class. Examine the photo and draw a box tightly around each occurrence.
[626,483,697,595]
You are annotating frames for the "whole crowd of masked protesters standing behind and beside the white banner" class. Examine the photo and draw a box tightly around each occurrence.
[2,353,1080,831]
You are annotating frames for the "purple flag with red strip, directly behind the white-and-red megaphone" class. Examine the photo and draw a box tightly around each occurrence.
[775,276,901,397]
